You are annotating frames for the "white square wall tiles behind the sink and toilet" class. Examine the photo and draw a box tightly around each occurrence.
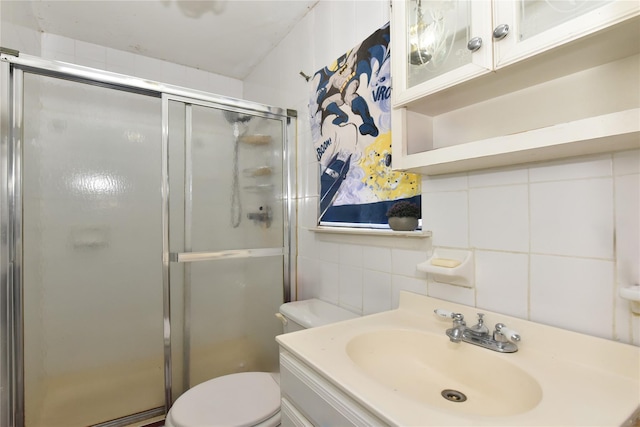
[298,150,640,345]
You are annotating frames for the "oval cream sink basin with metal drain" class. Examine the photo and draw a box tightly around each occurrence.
[346,329,542,416]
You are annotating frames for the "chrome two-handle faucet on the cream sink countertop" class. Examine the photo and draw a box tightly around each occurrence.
[434,310,520,353]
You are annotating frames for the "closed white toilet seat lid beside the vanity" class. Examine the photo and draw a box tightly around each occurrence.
[171,372,280,427]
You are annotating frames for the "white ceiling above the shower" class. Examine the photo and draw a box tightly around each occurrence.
[0,0,318,80]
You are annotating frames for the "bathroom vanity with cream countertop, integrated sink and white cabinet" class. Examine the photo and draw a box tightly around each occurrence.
[277,292,640,426]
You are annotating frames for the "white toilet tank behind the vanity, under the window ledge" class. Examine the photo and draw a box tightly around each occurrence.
[278,298,360,333]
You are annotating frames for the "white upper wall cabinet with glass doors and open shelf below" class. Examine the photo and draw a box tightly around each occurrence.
[391,0,640,174]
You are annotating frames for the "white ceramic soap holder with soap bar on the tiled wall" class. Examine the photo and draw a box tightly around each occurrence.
[417,248,474,288]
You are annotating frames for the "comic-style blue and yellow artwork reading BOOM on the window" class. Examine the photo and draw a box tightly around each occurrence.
[309,23,421,227]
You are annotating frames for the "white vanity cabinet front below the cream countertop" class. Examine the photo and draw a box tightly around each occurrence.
[280,349,387,427]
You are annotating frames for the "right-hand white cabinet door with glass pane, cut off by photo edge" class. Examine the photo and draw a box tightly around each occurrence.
[494,0,640,68]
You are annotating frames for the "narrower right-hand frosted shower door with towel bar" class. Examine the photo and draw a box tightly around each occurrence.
[164,98,288,399]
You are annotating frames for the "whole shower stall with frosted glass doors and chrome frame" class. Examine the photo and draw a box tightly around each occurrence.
[0,54,295,427]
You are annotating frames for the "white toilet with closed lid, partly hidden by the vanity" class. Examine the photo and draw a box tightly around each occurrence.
[165,298,359,427]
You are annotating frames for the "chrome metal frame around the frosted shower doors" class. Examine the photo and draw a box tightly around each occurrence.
[0,49,297,427]
